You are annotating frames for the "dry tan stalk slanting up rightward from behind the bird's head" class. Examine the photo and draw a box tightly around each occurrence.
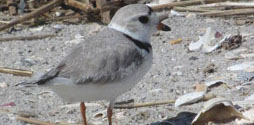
[152,0,234,10]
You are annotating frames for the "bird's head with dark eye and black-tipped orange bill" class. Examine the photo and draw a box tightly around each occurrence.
[108,4,171,42]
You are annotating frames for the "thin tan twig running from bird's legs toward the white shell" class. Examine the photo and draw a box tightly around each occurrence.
[114,100,175,109]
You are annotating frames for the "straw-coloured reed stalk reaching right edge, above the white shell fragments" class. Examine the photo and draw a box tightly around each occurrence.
[199,9,254,17]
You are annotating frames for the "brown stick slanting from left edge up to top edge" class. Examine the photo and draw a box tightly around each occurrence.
[0,0,63,31]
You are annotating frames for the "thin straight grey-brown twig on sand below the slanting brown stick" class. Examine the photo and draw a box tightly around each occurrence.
[0,34,56,42]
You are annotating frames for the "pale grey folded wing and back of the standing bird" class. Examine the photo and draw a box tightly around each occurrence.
[27,28,144,84]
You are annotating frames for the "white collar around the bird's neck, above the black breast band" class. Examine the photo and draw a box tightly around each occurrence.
[108,23,151,43]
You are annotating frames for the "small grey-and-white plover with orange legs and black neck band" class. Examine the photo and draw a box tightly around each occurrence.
[17,4,171,125]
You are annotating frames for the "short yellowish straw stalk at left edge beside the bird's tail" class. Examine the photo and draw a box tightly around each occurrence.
[0,67,33,77]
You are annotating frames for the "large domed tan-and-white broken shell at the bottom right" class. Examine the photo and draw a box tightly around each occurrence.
[192,97,245,125]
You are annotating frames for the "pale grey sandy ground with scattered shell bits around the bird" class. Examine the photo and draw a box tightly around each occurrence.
[0,14,254,125]
